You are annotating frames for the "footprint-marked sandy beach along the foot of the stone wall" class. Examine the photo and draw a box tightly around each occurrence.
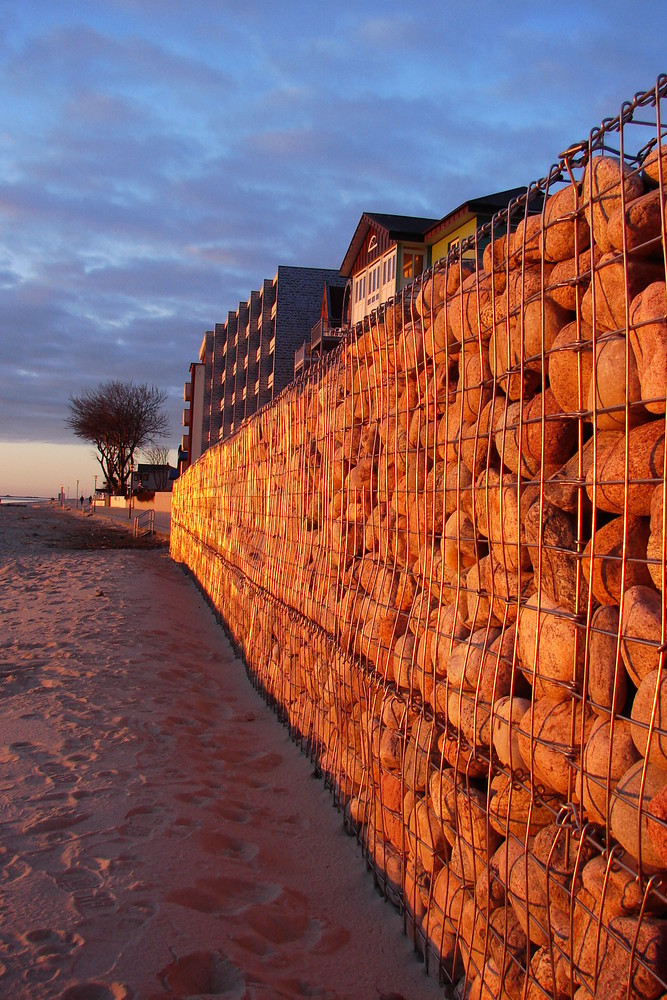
[0,506,443,1000]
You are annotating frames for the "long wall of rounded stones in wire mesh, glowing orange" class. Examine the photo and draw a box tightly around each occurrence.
[171,77,667,1000]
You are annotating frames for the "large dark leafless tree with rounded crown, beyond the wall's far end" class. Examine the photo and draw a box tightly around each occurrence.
[65,379,169,494]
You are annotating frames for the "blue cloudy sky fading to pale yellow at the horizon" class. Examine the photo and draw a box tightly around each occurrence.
[0,0,667,495]
